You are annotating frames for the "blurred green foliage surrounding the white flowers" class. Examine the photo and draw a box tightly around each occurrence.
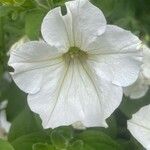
[0,0,150,150]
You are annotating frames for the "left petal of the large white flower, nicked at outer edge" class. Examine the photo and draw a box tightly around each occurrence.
[8,41,62,93]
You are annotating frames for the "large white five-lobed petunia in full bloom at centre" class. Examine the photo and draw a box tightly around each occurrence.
[8,0,141,128]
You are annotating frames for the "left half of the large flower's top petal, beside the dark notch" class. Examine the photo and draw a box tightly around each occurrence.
[41,7,72,52]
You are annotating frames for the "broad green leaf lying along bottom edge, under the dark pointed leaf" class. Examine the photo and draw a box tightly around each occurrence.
[11,131,51,150]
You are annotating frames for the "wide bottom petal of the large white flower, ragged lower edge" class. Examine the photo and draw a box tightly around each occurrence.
[28,59,122,128]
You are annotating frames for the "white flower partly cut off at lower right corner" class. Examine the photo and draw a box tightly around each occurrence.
[128,105,150,150]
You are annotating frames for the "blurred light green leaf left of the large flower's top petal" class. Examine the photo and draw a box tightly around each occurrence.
[25,10,45,40]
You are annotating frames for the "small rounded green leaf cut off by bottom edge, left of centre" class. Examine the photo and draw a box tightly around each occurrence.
[32,143,55,150]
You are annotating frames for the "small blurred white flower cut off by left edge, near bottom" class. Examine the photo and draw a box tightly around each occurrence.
[0,101,11,138]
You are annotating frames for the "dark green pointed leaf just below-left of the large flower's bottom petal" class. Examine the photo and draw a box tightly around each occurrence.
[8,108,43,141]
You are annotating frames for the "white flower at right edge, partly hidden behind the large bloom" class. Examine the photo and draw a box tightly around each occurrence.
[124,45,150,99]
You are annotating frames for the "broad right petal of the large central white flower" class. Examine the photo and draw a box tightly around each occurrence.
[87,25,142,87]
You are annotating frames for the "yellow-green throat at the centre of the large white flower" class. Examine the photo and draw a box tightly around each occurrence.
[64,47,87,59]
